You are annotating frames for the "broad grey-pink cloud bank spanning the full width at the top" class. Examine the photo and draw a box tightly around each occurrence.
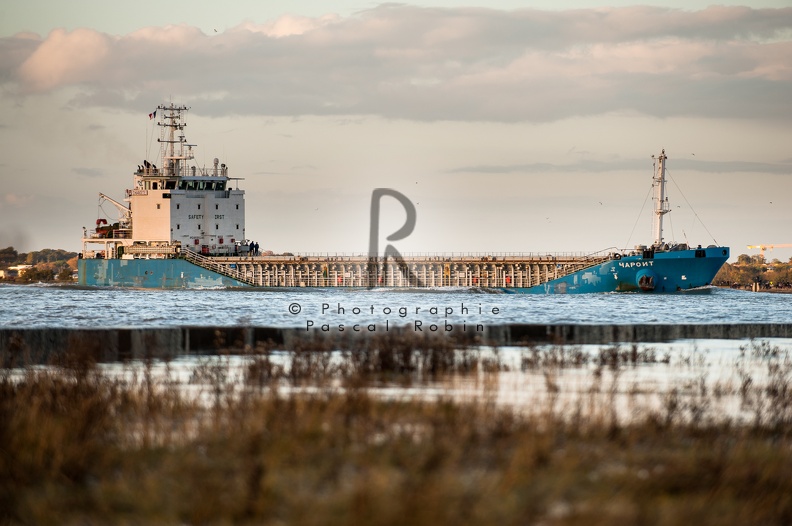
[0,5,792,122]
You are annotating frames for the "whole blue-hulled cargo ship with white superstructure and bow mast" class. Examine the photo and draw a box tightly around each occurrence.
[78,104,729,294]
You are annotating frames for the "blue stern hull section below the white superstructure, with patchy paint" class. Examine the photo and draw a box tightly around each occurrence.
[77,259,248,289]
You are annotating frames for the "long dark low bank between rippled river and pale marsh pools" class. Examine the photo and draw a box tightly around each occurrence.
[0,323,792,367]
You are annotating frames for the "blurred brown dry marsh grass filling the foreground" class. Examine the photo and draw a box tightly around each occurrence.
[0,337,792,525]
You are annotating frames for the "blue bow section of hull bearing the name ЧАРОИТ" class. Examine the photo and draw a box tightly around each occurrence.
[501,247,729,294]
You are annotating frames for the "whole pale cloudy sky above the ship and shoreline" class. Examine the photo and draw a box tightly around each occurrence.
[0,0,792,261]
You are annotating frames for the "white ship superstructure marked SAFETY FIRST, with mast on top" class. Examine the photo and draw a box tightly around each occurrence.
[83,104,245,259]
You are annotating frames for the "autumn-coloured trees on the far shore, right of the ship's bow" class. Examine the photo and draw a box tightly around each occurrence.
[713,254,792,289]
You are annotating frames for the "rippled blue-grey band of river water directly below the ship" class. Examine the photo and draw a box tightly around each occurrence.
[0,284,792,330]
